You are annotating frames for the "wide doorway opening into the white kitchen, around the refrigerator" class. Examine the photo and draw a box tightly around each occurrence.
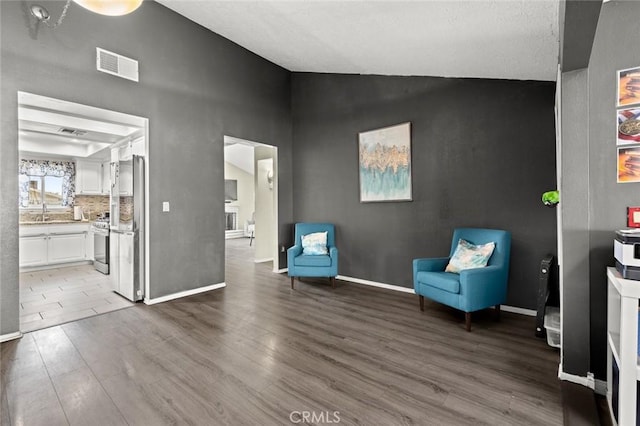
[17,92,149,332]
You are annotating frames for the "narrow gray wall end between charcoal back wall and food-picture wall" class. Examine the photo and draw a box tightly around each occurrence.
[559,69,591,377]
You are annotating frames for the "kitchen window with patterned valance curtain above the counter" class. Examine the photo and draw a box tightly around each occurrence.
[18,160,75,208]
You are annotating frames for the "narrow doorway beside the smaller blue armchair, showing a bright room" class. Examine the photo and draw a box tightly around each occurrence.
[224,136,279,271]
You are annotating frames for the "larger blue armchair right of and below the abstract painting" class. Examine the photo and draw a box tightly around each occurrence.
[413,228,511,331]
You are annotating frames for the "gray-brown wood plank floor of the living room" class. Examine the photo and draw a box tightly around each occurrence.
[0,239,562,425]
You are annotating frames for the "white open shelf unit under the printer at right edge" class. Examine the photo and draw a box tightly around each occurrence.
[607,267,640,426]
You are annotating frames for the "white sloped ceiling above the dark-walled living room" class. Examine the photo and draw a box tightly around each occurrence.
[157,0,559,81]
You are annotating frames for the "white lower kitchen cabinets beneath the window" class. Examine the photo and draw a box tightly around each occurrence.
[19,223,93,268]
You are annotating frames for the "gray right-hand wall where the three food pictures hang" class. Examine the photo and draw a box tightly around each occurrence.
[582,1,640,380]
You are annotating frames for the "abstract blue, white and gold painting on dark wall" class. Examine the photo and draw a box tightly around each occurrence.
[359,123,411,203]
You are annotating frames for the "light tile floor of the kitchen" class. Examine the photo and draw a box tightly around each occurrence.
[20,265,133,333]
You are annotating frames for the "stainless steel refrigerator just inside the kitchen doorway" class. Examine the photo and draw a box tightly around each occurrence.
[109,155,145,302]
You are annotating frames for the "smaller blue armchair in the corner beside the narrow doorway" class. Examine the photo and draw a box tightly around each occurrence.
[287,223,338,288]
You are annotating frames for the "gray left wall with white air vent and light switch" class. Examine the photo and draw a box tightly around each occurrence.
[0,1,292,334]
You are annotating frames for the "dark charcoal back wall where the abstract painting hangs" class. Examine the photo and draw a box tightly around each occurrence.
[292,73,556,309]
